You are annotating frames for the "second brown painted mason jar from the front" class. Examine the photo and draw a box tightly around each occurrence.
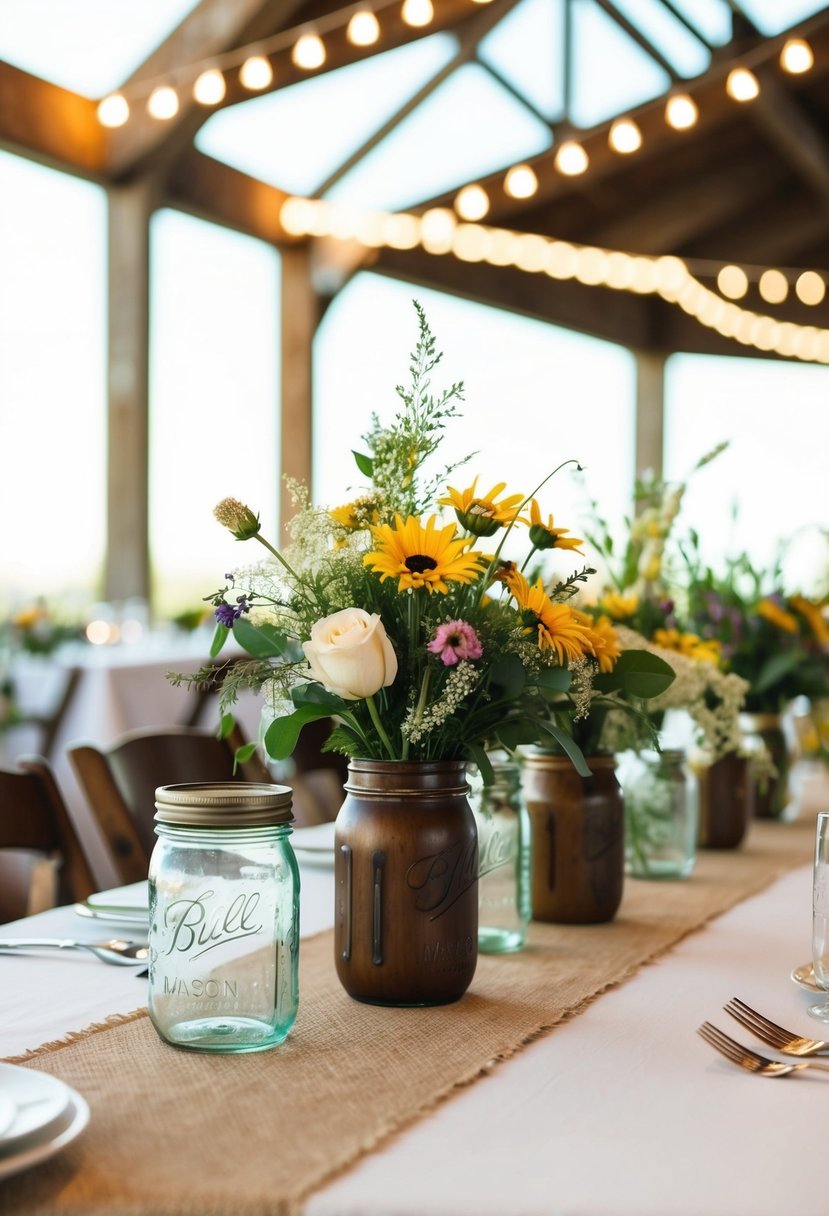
[521,751,625,924]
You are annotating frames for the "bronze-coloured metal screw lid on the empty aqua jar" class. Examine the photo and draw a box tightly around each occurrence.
[156,781,293,828]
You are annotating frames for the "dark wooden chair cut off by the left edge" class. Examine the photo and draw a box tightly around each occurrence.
[0,756,95,922]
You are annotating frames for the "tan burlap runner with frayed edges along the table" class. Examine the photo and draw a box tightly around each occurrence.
[0,821,814,1216]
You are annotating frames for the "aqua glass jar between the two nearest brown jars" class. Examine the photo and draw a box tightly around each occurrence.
[467,760,531,955]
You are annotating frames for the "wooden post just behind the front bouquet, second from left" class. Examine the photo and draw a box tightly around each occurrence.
[280,244,320,544]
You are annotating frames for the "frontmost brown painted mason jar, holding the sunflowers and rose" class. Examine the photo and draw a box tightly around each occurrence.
[334,760,478,1006]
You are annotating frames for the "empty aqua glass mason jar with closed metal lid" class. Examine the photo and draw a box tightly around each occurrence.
[148,782,299,1052]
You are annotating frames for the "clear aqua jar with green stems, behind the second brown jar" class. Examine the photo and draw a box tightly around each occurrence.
[617,748,699,878]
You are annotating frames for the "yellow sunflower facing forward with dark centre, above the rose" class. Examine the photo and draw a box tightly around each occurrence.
[363,516,486,595]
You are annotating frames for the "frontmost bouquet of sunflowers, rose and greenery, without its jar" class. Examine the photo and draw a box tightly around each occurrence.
[182,303,670,781]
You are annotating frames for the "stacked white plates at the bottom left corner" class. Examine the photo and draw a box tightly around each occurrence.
[0,1064,89,1178]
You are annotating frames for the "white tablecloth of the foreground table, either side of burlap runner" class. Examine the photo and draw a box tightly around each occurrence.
[0,867,829,1216]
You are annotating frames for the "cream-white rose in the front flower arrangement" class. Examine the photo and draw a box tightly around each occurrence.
[303,608,397,700]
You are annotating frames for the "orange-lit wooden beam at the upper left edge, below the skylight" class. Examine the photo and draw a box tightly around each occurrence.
[0,63,106,179]
